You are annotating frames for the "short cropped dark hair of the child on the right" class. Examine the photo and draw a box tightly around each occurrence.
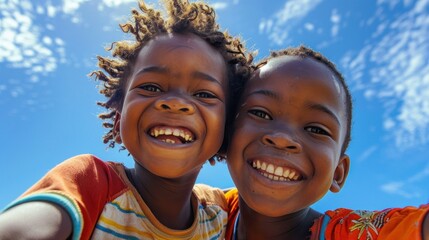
[253,45,353,154]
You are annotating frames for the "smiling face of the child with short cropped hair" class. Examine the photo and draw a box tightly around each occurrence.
[228,56,349,217]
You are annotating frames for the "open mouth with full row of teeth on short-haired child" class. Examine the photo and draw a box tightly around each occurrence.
[250,160,303,182]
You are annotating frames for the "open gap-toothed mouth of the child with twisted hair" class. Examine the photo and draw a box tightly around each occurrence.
[149,126,195,144]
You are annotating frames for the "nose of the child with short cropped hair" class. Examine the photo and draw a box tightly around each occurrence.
[262,132,302,153]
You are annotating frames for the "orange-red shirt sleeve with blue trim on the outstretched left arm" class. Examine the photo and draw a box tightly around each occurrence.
[4,155,122,239]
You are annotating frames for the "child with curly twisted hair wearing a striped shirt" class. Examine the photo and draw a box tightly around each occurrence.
[0,0,251,239]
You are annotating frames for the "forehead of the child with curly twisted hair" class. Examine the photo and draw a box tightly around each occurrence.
[128,33,228,85]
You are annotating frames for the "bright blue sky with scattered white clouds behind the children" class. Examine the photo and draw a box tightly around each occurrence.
[0,0,429,211]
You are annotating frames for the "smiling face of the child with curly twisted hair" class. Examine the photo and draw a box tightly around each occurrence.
[115,34,228,178]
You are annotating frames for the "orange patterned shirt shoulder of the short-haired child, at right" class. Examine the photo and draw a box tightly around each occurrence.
[313,205,429,239]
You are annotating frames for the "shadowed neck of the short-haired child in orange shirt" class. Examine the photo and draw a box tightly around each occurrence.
[237,198,321,240]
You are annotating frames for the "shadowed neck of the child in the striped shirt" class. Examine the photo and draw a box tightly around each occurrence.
[129,163,199,230]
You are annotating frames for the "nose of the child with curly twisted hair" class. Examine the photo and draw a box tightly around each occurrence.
[155,95,195,114]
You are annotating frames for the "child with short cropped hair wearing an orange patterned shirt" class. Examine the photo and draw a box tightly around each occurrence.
[222,46,429,240]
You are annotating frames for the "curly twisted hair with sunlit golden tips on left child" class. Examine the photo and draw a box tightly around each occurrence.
[90,0,253,158]
